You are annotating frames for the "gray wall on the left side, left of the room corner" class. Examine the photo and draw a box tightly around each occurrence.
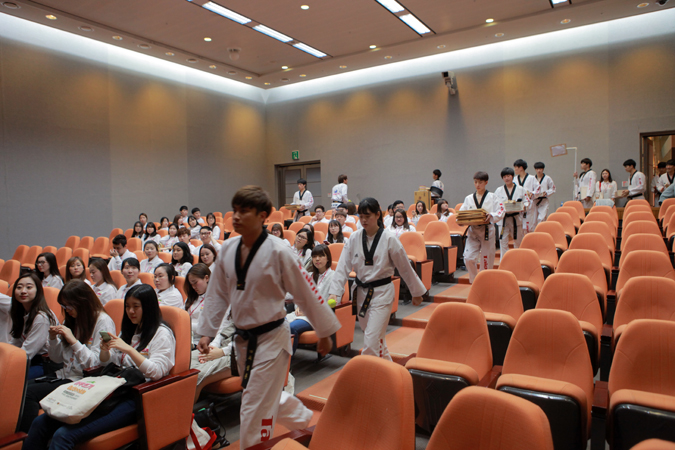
[0,39,272,259]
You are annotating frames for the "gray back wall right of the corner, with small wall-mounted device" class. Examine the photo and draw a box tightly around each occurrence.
[267,34,675,211]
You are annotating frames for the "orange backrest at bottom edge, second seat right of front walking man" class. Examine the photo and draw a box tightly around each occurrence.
[426,386,553,450]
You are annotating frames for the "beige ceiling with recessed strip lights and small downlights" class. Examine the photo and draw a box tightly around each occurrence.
[0,0,675,88]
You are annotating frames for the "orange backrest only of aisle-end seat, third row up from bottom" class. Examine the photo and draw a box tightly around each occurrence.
[466,269,523,321]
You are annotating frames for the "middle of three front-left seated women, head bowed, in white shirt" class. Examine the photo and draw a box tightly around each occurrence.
[19,280,115,433]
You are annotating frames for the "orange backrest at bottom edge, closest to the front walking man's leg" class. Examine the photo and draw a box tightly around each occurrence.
[312,356,415,450]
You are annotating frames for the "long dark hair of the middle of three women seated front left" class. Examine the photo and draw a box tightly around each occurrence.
[58,279,104,345]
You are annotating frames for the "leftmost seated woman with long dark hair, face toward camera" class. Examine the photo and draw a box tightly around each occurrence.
[9,272,59,380]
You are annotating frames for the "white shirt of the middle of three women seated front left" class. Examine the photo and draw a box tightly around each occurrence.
[49,312,117,381]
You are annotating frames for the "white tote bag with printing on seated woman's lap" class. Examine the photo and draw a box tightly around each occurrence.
[40,375,127,424]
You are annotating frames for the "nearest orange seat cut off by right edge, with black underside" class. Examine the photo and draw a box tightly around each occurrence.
[608,319,675,450]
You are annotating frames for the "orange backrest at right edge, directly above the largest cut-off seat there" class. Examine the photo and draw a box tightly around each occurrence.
[613,277,675,329]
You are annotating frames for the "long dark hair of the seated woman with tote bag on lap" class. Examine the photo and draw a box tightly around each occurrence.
[120,284,168,351]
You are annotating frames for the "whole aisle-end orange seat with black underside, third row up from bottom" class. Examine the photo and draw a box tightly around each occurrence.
[466,269,523,366]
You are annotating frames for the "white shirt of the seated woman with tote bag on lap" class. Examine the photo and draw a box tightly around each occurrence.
[101,325,176,381]
